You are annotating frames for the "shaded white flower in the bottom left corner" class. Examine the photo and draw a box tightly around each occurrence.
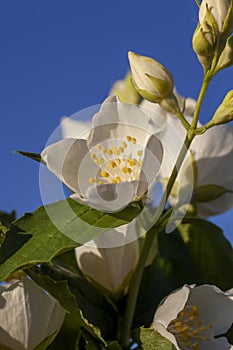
[0,277,65,350]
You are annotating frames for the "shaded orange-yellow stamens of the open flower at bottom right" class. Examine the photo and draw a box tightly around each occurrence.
[168,305,213,350]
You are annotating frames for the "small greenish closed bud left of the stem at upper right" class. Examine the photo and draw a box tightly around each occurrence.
[192,22,217,69]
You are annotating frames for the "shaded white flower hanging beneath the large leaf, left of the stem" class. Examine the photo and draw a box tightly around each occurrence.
[75,223,139,294]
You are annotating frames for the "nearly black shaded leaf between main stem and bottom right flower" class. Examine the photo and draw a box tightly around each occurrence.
[134,226,200,328]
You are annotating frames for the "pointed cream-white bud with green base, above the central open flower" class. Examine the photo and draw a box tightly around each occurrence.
[129,52,174,103]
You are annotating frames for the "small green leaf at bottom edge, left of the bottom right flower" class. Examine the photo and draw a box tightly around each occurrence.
[133,327,175,350]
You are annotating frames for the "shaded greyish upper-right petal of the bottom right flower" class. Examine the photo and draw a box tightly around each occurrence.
[188,285,233,336]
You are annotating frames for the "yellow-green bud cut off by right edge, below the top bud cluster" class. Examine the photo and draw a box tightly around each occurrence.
[211,90,233,125]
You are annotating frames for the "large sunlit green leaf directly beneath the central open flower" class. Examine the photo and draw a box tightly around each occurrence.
[0,199,140,280]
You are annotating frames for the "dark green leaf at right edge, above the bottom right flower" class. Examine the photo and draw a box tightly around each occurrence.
[177,219,233,290]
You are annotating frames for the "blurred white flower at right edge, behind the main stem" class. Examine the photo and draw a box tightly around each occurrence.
[173,125,233,217]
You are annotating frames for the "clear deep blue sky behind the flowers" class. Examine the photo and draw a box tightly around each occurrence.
[0,0,233,241]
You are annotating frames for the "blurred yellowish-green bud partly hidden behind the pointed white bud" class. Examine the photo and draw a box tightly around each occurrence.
[109,72,142,104]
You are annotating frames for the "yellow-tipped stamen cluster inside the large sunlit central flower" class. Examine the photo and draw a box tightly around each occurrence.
[89,135,143,185]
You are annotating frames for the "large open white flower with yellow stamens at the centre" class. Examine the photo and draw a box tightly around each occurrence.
[41,96,163,211]
